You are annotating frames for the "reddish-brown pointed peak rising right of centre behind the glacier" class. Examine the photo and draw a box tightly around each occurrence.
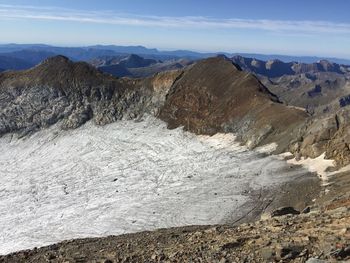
[159,58,307,150]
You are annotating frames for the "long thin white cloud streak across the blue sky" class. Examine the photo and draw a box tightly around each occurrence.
[0,4,350,34]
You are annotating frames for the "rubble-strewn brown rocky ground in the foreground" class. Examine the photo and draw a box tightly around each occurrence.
[0,174,350,263]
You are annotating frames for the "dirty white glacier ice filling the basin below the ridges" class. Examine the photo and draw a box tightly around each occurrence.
[0,117,306,254]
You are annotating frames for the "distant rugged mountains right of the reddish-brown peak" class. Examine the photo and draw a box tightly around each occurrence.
[227,56,350,115]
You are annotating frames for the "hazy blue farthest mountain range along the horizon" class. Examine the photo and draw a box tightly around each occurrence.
[0,44,350,65]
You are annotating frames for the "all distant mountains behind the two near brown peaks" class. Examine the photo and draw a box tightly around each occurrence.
[0,44,350,118]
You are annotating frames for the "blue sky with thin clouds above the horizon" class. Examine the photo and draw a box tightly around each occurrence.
[0,0,350,59]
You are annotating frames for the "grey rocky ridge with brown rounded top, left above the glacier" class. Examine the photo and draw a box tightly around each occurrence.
[0,56,182,137]
